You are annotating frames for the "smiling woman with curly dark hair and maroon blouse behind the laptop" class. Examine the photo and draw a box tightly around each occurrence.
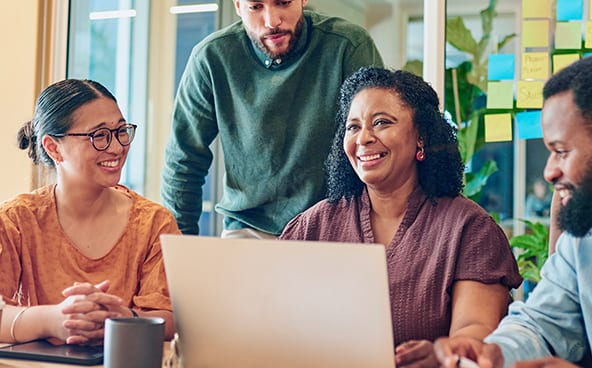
[281,68,522,367]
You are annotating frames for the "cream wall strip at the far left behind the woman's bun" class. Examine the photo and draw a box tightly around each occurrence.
[0,0,39,201]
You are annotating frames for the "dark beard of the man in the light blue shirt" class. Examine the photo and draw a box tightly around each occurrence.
[558,162,592,238]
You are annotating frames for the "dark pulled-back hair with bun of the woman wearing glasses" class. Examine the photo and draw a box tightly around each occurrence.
[17,79,117,167]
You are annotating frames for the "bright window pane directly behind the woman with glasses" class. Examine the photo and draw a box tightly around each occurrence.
[66,0,149,193]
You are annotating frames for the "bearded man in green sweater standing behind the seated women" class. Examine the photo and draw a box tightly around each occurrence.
[161,0,382,238]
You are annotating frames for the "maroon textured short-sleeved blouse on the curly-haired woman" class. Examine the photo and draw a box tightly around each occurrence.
[280,189,522,346]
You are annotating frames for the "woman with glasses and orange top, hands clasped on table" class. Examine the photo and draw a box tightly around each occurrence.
[0,79,180,344]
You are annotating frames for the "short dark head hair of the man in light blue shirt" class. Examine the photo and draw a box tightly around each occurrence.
[543,57,592,131]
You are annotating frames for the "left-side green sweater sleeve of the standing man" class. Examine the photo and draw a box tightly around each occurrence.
[161,45,218,234]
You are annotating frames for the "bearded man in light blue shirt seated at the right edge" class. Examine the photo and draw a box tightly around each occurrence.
[436,57,592,368]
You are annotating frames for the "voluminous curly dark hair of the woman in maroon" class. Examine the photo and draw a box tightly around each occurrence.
[326,67,464,202]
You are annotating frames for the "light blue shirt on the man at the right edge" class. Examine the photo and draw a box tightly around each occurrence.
[485,231,592,366]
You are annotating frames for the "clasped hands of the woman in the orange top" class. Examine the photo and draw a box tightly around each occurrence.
[56,281,126,345]
